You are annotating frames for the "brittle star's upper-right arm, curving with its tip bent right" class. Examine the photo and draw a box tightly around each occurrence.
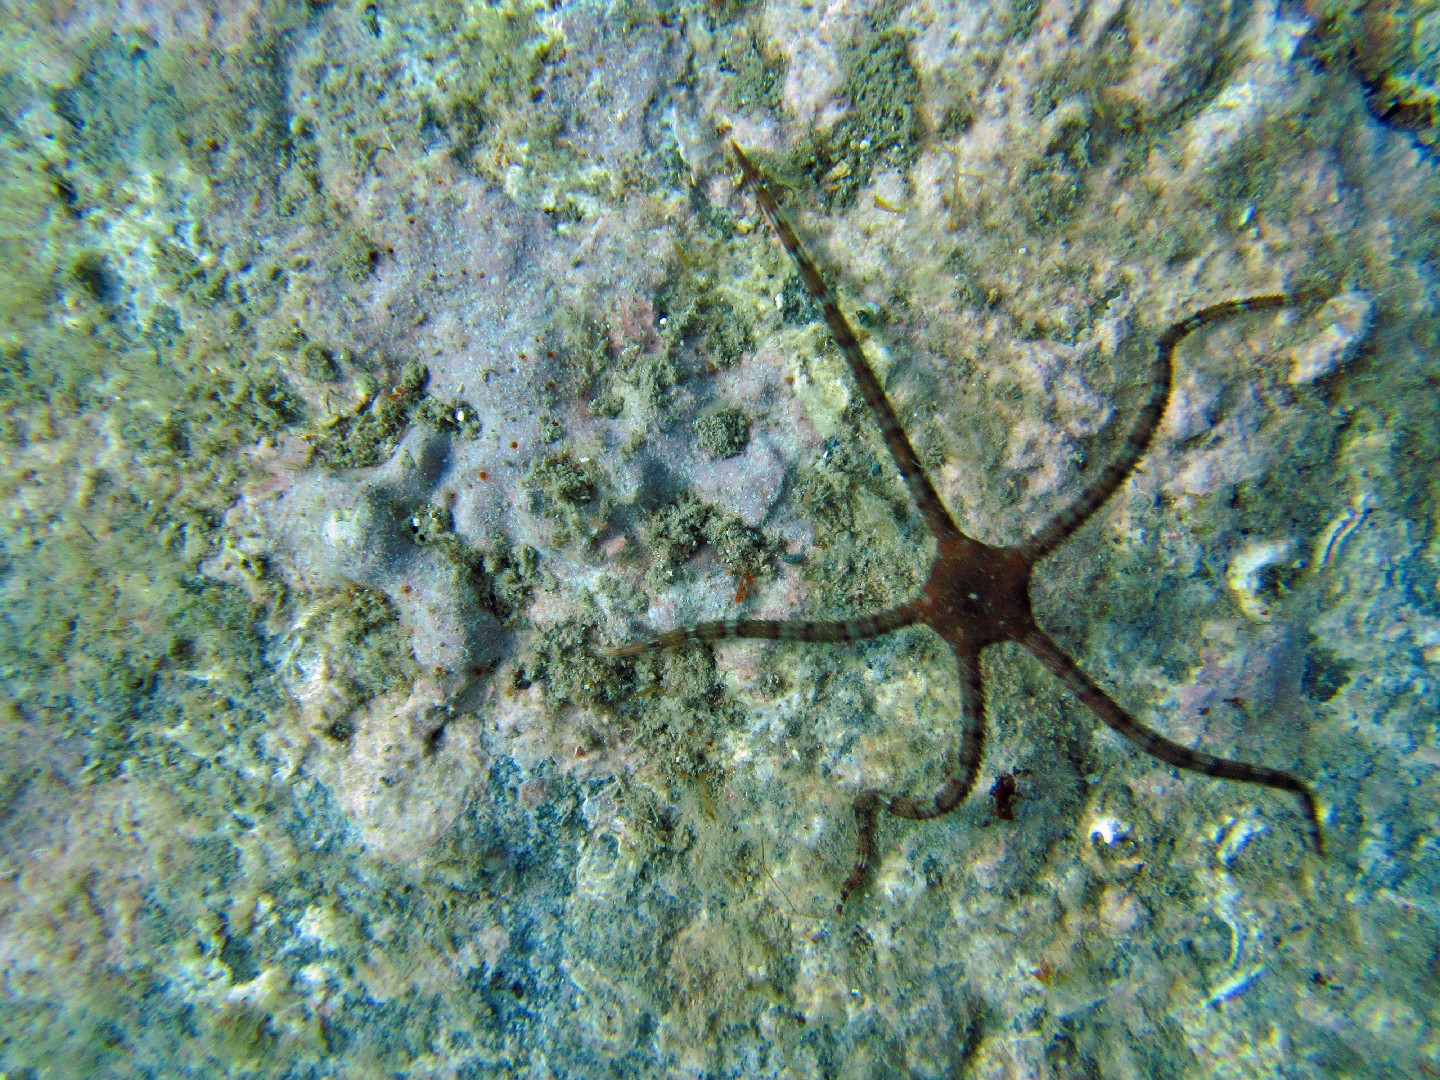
[1020,294,1293,563]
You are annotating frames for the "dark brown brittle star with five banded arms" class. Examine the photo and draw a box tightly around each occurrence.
[611,143,1325,913]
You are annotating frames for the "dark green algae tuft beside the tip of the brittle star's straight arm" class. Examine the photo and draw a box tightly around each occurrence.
[808,13,920,209]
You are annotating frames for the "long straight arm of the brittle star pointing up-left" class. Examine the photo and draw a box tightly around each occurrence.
[730,140,959,550]
